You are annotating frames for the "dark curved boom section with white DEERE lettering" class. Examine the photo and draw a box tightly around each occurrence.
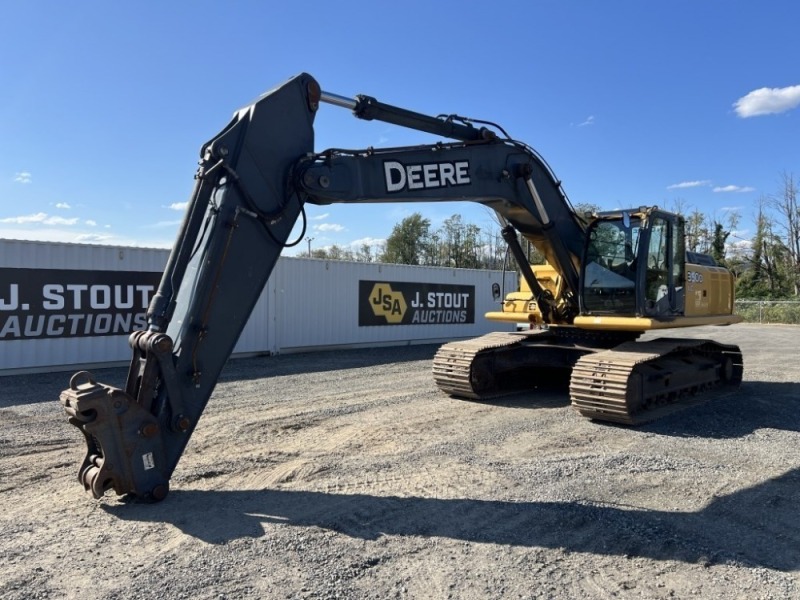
[298,139,585,296]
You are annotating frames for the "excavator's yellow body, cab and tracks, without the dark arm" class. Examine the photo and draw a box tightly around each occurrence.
[433,207,743,425]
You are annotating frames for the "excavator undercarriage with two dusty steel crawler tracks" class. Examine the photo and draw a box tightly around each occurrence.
[433,327,743,425]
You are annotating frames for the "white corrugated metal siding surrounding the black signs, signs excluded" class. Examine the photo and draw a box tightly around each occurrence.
[0,240,516,372]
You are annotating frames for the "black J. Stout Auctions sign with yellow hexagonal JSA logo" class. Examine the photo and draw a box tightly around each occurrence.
[358,280,475,326]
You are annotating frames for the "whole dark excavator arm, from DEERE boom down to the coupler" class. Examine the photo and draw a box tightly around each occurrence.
[56,74,584,500]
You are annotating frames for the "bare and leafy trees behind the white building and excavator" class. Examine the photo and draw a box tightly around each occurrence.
[298,173,800,300]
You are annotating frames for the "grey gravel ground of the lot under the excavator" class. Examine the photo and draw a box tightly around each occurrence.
[0,324,800,600]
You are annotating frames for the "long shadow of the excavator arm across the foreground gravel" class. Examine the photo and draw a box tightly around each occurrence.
[103,468,800,571]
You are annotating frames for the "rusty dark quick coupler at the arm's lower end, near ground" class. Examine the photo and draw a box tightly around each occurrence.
[60,371,169,501]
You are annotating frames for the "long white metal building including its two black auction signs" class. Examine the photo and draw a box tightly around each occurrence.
[0,240,516,374]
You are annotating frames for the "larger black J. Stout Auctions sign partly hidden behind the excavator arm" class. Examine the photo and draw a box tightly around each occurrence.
[0,269,161,341]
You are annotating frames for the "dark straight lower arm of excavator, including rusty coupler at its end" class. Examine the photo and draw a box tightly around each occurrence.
[61,75,317,500]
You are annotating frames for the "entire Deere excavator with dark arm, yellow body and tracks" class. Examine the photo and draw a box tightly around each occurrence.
[61,73,742,501]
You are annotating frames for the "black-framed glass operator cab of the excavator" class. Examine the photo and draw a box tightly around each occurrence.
[580,208,686,319]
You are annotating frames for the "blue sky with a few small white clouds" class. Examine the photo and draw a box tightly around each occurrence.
[0,0,800,250]
